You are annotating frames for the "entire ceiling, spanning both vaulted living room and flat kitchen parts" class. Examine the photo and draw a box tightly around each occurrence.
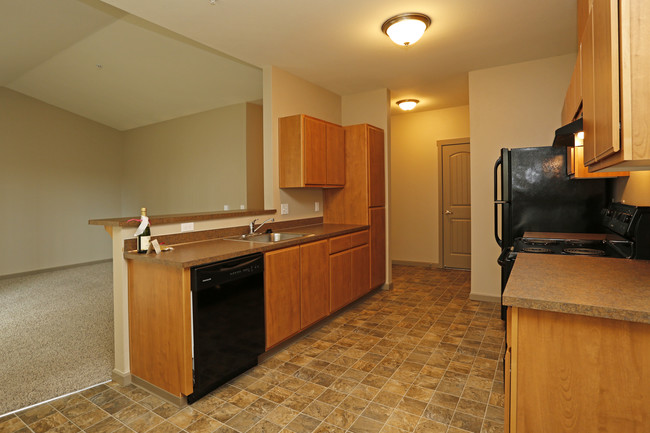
[0,0,577,125]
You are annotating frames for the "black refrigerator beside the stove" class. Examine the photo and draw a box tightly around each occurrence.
[494,146,610,318]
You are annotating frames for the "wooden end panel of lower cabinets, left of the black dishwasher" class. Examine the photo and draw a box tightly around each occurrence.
[128,260,186,396]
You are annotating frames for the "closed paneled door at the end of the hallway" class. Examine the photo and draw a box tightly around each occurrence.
[438,138,471,269]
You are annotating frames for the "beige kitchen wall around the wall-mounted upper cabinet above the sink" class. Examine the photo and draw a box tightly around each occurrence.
[264,66,341,219]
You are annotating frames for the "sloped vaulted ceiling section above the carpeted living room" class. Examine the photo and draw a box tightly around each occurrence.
[0,0,262,130]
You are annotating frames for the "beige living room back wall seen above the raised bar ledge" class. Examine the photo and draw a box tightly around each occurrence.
[122,104,247,215]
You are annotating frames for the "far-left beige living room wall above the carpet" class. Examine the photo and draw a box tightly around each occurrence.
[0,87,122,275]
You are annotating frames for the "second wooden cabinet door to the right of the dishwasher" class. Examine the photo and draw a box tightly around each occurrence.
[300,240,330,328]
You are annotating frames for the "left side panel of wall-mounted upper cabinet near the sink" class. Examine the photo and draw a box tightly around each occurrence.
[278,114,303,188]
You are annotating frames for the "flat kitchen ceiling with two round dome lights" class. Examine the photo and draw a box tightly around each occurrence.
[97,0,577,110]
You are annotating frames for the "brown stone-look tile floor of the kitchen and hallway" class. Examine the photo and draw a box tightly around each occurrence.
[0,266,504,433]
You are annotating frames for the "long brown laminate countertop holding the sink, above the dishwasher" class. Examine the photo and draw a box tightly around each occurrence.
[124,224,368,268]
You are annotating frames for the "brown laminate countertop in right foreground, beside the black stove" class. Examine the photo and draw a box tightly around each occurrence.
[503,253,650,324]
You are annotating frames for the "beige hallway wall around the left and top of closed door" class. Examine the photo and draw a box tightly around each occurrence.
[391,106,473,264]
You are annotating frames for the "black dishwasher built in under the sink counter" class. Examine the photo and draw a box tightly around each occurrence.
[187,253,265,403]
